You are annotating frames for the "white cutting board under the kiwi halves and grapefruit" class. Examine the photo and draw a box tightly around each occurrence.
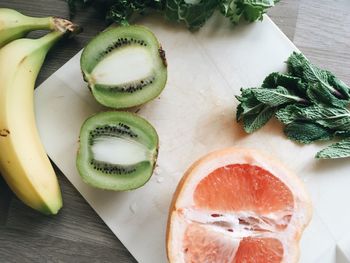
[35,14,350,263]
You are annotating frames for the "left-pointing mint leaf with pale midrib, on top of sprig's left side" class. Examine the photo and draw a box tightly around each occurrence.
[252,86,305,107]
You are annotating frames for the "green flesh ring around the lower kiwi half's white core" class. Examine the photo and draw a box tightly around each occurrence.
[76,111,159,191]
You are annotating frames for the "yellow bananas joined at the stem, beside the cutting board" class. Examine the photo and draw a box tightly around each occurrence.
[0,8,79,214]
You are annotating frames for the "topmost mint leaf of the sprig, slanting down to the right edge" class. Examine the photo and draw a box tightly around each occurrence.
[287,52,350,106]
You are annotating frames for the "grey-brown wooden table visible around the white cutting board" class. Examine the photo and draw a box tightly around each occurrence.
[0,0,350,263]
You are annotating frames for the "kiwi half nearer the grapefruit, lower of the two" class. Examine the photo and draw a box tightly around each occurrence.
[76,111,158,191]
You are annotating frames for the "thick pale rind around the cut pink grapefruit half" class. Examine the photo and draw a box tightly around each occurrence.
[167,148,312,263]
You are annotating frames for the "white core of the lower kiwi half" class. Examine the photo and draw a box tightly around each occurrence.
[91,136,150,165]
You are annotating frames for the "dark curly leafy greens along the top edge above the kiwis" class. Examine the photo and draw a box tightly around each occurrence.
[66,0,279,29]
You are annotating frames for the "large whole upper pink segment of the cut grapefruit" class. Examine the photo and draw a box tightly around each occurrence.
[194,164,294,216]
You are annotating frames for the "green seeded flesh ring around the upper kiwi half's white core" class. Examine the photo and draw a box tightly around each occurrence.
[80,25,167,109]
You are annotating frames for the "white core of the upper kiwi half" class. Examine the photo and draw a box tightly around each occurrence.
[91,45,154,86]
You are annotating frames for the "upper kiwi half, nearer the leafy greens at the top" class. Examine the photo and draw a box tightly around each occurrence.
[80,26,167,109]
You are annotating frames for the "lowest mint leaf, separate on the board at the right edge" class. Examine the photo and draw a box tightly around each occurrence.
[316,138,350,159]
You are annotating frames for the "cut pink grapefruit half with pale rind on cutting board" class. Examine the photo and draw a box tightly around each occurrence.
[167,148,312,263]
